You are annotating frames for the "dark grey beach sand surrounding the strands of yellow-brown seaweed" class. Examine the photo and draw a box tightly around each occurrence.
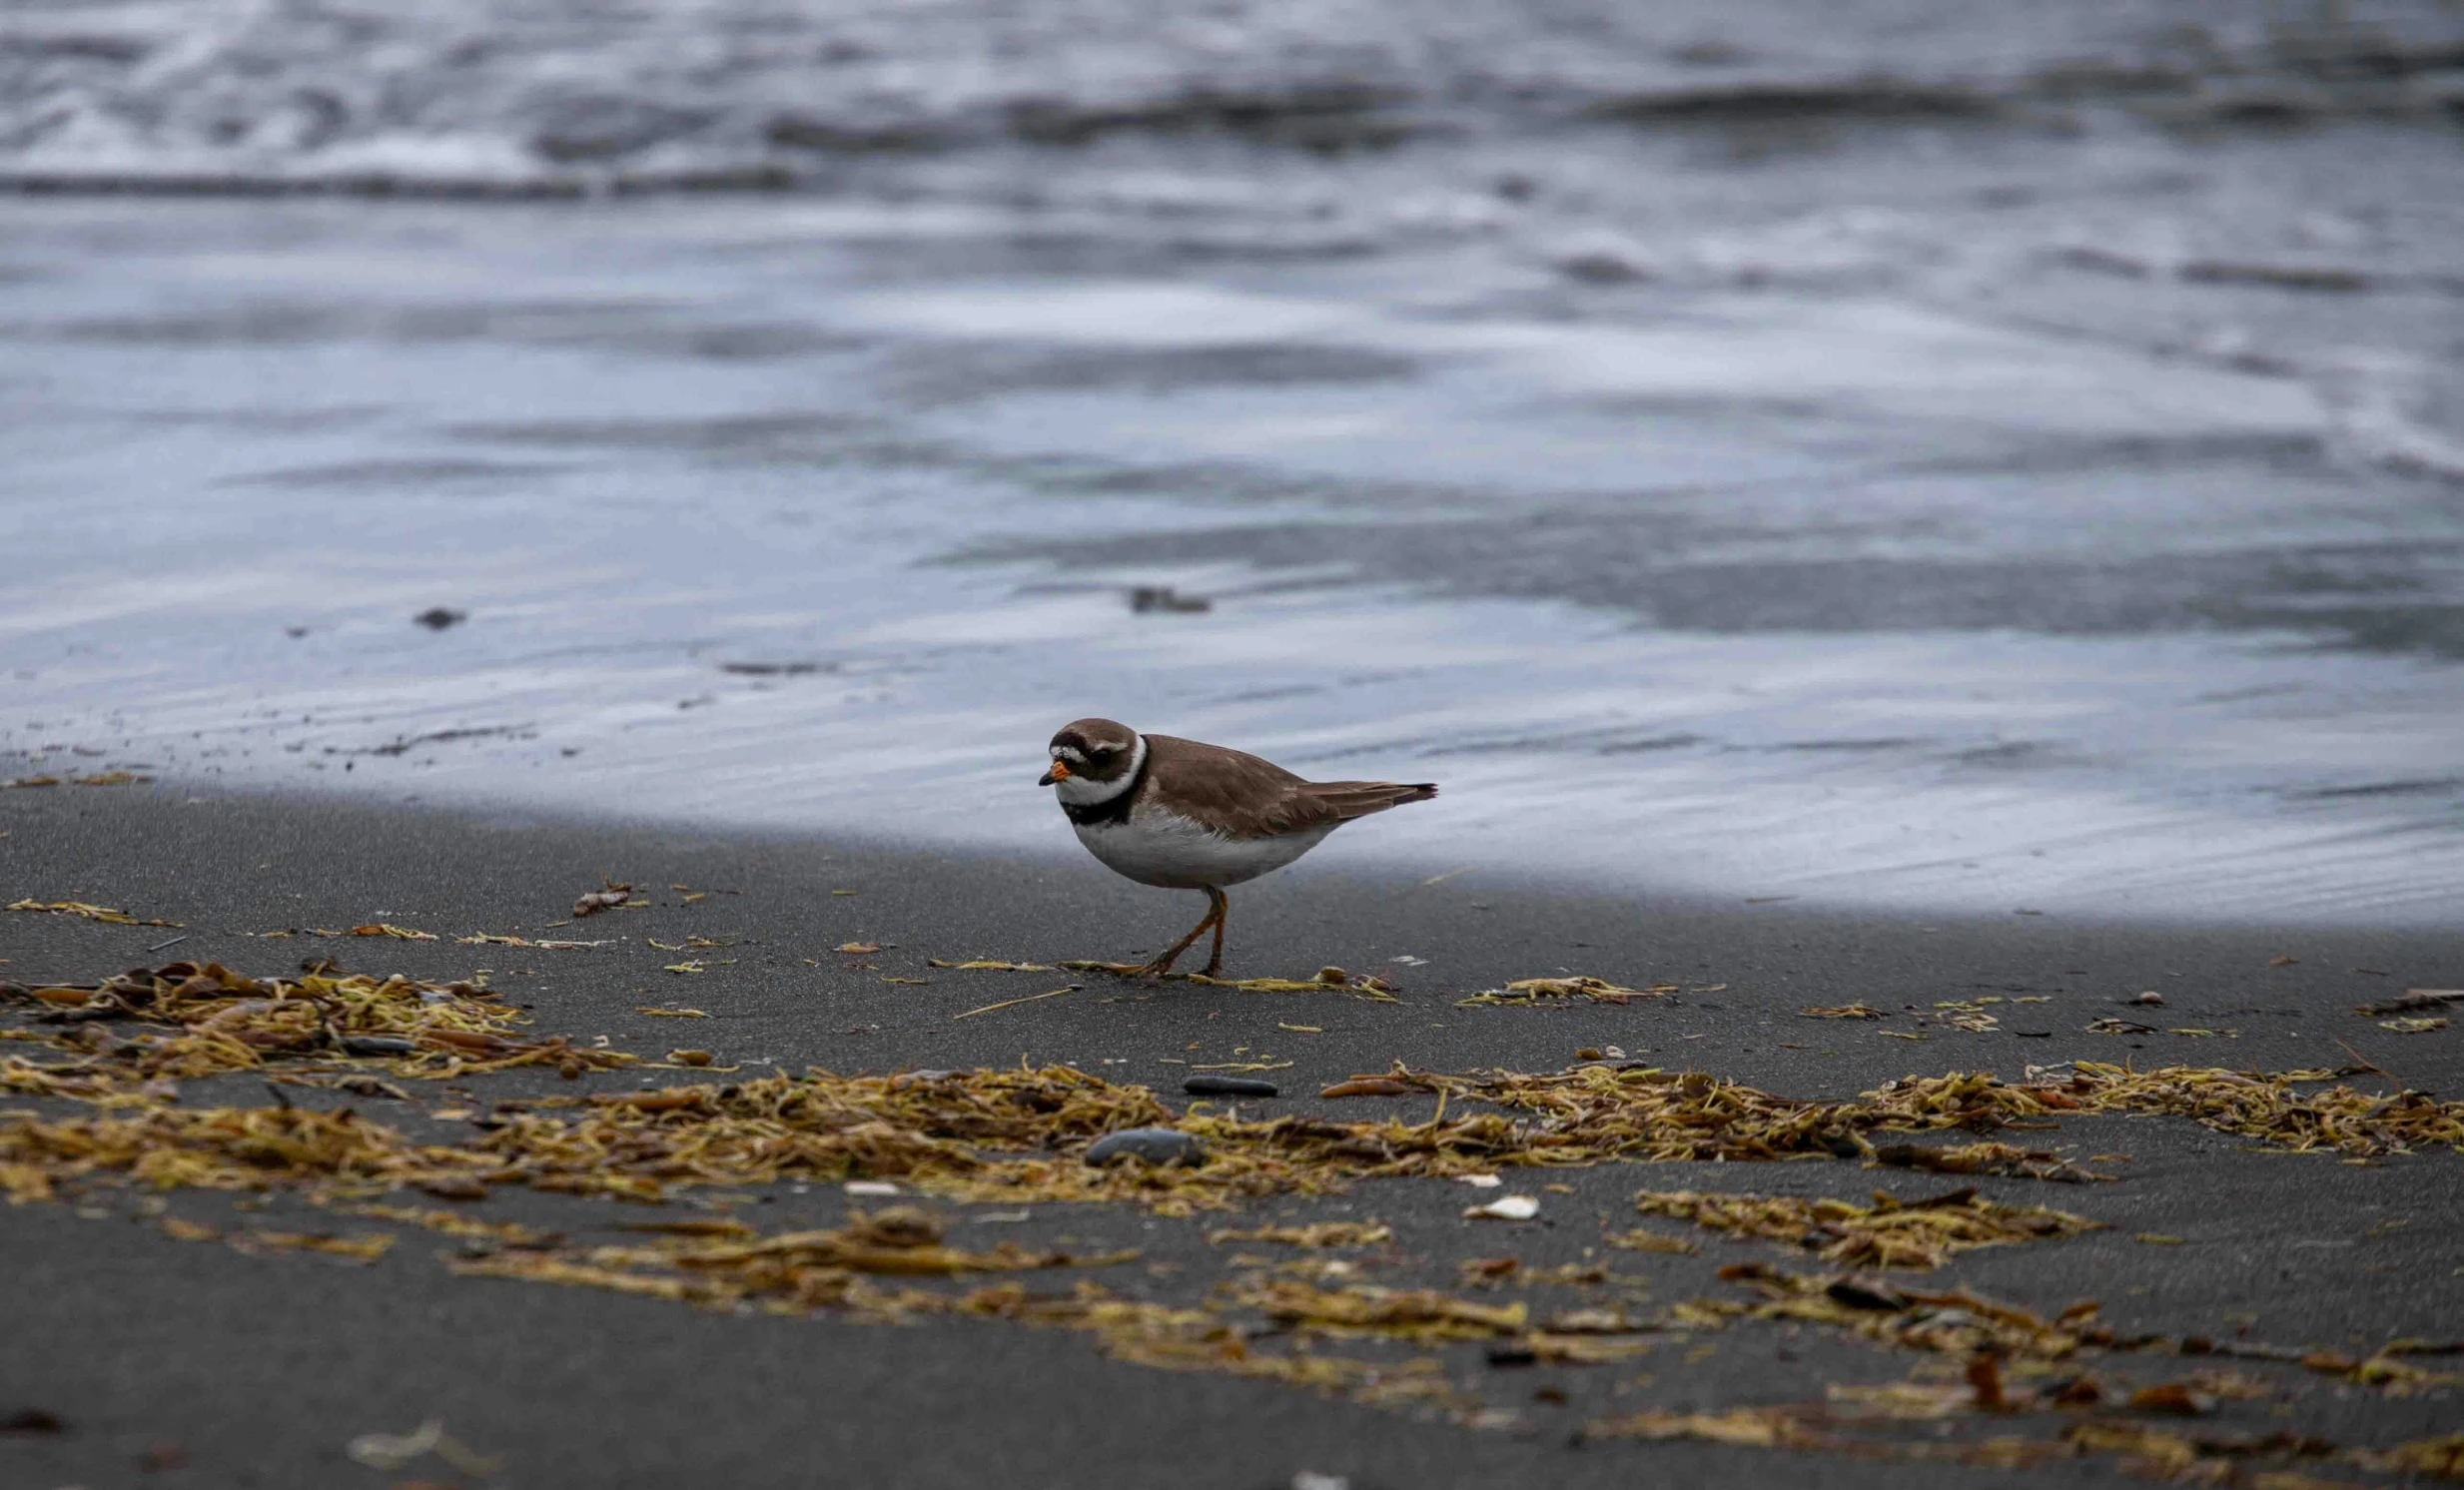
[0,786,2464,1490]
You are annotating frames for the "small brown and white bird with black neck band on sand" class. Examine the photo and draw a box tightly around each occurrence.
[1038,719,1436,978]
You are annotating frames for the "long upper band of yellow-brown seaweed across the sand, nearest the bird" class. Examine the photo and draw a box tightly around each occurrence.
[0,963,2464,1221]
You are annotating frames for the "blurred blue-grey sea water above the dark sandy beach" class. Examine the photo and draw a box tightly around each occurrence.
[0,0,2464,921]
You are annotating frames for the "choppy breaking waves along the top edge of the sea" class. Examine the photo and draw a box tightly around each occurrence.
[0,0,2464,195]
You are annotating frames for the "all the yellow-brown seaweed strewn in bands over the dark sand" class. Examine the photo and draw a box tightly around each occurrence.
[0,963,2464,1480]
